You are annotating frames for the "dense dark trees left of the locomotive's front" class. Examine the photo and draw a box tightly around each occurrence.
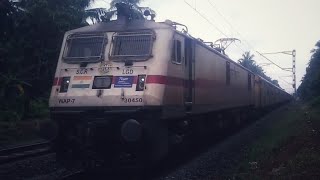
[0,0,91,120]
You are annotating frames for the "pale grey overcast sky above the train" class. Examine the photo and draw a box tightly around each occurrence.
[92,0,320,93]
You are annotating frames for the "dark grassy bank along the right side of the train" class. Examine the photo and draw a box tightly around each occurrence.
[232,102,320,179]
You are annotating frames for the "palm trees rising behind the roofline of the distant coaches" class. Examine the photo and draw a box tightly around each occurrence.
[238,52,280,87]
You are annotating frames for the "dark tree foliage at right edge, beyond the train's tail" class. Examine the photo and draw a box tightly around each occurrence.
[298,41,320,100]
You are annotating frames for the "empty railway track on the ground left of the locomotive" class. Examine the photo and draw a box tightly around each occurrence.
[0,141,52,165]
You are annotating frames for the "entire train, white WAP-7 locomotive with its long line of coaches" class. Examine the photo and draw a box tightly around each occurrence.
[49,4,291,169]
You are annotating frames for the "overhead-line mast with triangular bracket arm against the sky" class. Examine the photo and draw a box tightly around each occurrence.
[258,49,297,96]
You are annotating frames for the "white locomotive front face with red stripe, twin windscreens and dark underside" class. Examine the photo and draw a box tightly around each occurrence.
[49,20,172,165]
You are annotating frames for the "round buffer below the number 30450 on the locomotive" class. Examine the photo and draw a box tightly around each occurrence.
[121,119,142,142]
